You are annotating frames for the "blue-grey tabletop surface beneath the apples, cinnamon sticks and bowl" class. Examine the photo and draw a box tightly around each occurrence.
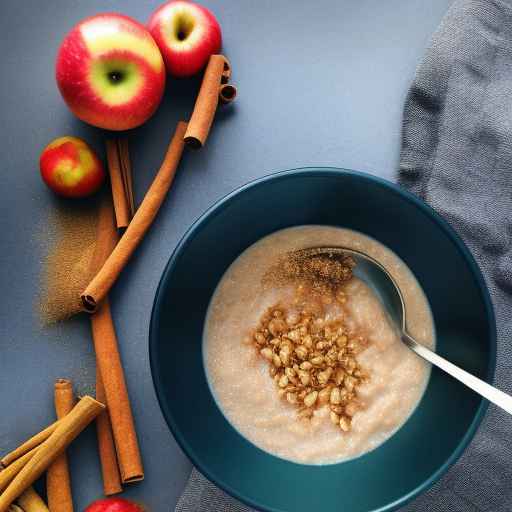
[0,0,451,512]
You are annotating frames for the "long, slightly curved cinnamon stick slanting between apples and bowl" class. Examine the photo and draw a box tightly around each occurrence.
[81,121,188,312]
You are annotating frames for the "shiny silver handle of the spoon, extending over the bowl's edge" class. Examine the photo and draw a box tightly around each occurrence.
[402,332,512,414]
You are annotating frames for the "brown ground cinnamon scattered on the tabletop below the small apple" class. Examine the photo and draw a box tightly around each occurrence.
[39,194,101,324]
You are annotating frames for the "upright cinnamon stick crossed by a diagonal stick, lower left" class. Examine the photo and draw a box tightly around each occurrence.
[46,379,75,512]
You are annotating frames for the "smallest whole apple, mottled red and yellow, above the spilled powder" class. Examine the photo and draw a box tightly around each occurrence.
[39,137,105,197]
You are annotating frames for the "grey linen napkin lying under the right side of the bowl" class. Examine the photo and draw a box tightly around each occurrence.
[176,0,512,512]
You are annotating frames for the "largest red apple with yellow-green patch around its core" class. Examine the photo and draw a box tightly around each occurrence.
[56,14,165,130]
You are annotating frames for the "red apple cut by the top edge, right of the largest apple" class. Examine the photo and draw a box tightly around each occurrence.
[148,0,222,77]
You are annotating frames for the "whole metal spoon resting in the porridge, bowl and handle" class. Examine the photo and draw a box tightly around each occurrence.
[297,247,512,414]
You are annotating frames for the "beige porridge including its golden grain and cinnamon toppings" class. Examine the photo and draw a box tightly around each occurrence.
[203,226,434,464]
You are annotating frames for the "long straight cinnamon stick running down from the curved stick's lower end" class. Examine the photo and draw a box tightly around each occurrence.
[91,299,144,483]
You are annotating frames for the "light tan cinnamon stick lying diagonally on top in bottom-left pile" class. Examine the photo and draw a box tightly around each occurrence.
[0,396,105,512]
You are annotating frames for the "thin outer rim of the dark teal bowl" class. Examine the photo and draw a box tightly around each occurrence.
[149,166,497,512]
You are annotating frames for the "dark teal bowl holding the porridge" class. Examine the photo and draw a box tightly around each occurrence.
[149,168,496,512]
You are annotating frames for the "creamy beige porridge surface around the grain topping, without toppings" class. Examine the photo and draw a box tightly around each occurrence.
[203,226,434,464]
